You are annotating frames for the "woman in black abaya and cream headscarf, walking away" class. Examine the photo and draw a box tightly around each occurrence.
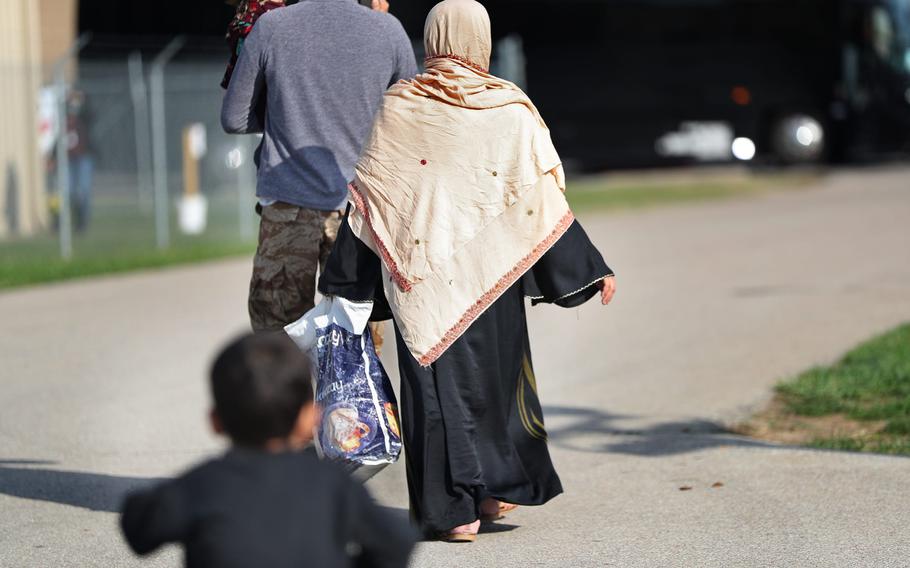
[320,0,615,542]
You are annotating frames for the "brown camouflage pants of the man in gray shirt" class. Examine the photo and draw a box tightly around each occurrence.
[249,203,341,331]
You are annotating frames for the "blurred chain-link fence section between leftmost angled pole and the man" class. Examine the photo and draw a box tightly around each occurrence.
[78,57,258,244]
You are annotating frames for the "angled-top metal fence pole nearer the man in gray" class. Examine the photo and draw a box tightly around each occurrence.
[149,36,186,249]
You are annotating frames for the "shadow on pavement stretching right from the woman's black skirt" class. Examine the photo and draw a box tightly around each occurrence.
[544,406,788,456]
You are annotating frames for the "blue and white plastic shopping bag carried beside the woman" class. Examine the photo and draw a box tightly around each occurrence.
[285,298,401,479]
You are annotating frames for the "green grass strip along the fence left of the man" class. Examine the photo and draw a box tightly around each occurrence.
[0,198,256,289]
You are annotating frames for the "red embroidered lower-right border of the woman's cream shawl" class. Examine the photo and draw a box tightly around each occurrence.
[417,211,575,367]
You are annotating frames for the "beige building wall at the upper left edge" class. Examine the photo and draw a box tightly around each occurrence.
[0,0,77,238]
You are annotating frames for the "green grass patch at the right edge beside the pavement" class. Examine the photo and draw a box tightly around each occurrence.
[777,324,910,455]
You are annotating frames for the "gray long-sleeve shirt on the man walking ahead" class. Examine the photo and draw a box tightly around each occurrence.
[221,0,417,211]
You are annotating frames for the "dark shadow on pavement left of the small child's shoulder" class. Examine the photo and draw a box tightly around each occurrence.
[0,460,163,513]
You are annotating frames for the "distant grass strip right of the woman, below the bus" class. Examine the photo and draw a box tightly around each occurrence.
[566,174,816,212]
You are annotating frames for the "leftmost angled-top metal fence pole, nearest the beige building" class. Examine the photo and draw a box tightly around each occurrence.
[53,33,92,260]
